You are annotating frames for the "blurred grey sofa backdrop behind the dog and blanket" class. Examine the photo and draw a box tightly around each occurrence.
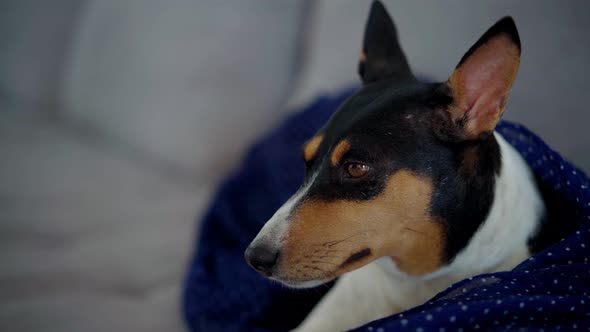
[0,0,590,331]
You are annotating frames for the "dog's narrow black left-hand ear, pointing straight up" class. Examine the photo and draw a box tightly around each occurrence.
[359,1,413,84]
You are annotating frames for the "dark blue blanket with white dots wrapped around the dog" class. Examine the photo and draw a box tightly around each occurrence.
[183,91,590,332]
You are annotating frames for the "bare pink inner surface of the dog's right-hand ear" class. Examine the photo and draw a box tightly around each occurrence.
[449,34,520,137]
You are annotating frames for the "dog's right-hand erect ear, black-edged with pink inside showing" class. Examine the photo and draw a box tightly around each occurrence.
[434,17,520,141]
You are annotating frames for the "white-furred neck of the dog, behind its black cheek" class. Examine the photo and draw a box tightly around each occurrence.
[379,134,545,280]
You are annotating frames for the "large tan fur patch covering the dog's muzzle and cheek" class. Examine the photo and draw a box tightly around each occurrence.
[277,170,444,282]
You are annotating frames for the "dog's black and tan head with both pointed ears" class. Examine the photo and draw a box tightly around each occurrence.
[245,2,520,287]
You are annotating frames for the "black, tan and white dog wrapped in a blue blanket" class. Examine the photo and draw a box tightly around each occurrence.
[244,1,572,331]
